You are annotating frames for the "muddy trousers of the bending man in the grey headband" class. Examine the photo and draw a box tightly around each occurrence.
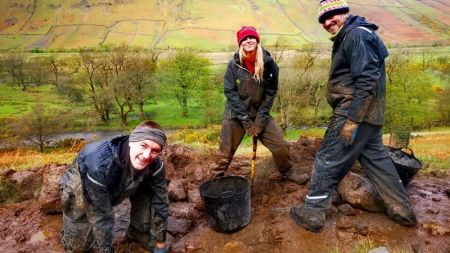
[61,163,155,253]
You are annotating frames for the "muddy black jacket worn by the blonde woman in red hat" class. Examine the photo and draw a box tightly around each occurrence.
[224,50,278,128]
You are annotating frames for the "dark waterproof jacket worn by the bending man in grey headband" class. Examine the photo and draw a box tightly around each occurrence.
[77,136,168,248]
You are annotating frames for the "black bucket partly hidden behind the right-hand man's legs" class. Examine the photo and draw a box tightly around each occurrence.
[386,146,422,187]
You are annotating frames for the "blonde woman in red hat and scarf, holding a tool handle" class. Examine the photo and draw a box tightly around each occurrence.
[217,26,308,184]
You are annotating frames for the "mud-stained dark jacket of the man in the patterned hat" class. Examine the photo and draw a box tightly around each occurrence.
[327,15,388,125]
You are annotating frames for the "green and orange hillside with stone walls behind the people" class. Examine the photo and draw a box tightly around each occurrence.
[0,0,450,51]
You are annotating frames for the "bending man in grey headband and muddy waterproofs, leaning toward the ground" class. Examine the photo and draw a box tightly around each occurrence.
[61,121,168,253]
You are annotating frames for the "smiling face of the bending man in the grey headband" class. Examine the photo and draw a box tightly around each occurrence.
[129,140,162,170]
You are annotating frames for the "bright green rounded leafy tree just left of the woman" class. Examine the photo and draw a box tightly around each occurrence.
[158,49,210,117]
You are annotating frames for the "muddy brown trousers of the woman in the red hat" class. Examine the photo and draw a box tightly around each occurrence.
[216,118,292,173]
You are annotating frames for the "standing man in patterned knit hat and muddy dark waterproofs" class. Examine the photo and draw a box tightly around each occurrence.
[290,0,417,232]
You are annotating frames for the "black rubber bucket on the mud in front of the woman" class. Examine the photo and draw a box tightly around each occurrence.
[200,176,251,233]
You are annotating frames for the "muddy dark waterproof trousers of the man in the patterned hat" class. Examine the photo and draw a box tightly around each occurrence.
[304,115,416,225]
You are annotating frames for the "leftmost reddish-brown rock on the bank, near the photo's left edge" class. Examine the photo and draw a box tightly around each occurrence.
[8,170,42,200]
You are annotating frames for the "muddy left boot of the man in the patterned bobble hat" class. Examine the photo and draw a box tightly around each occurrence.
[289,206,325,233]
